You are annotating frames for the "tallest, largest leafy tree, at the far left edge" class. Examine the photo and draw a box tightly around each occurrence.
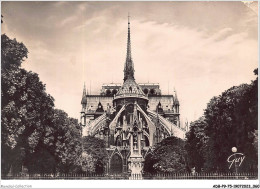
[1,34,54,174]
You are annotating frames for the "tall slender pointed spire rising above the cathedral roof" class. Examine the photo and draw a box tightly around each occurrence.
[124,13,135,81]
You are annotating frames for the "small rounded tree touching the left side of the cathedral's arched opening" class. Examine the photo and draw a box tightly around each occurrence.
[83,136,108,173]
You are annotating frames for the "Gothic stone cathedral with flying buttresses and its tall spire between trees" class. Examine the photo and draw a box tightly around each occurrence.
[80,17,186,175]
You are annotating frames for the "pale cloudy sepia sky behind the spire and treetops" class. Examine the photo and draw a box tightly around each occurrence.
[1,1,258,122]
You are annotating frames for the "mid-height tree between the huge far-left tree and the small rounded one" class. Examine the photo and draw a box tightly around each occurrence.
[46,109,82,173]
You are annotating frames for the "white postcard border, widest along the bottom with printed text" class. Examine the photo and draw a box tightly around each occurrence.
[0,0,260,188]
